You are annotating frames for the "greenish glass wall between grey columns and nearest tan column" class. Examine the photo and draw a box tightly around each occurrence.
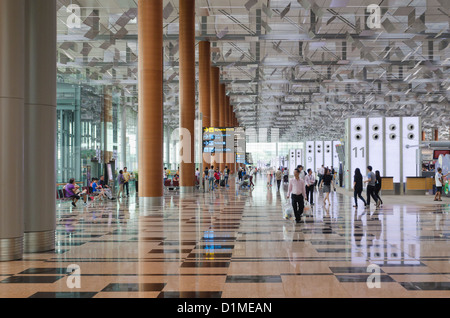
[56,82,138,185]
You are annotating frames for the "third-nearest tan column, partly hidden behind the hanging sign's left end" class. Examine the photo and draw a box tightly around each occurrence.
[199,41,211,170]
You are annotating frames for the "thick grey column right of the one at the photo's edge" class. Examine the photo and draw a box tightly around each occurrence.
[23,0,56,253]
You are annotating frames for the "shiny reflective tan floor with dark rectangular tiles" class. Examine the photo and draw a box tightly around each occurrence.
[0,175,450,298]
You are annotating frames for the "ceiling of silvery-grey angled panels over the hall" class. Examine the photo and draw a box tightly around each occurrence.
[58,0,450,141]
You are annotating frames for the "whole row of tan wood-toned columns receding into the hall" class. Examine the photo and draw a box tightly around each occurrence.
[138,0,238,206]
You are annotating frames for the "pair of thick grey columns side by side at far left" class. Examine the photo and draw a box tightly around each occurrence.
[0,0,56,261]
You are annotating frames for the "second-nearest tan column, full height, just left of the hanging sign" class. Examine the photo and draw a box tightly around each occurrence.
[179,0,195,192]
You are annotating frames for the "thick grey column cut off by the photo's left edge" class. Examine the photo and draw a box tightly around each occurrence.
[0,0,25,261]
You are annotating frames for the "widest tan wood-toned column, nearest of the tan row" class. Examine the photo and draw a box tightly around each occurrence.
[138,0,164,206]
